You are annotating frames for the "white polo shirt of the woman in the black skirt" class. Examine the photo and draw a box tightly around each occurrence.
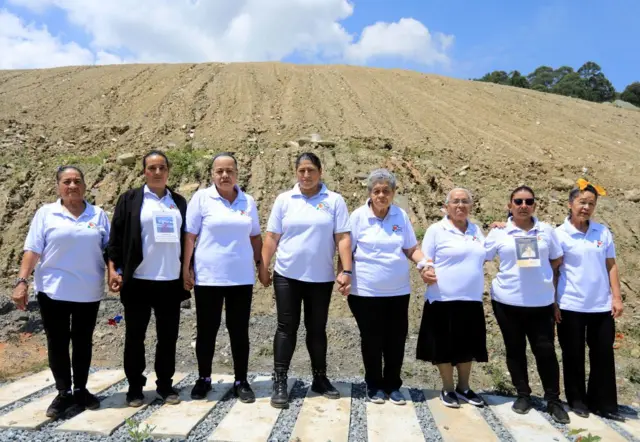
[422,217,486,302]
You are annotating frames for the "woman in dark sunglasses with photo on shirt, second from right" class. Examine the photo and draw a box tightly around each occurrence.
[485,186,569,424]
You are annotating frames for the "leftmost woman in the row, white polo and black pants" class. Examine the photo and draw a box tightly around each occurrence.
[13,166,109,419]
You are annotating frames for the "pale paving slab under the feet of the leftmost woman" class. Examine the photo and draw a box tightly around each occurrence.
[0,370,125,430]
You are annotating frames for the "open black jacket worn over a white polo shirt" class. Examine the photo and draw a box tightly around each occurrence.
[107,186,191,302]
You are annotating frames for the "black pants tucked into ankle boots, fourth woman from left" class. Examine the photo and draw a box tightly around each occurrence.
[273,272,333,372]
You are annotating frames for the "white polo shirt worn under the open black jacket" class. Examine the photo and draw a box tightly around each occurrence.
[133,184,182,281]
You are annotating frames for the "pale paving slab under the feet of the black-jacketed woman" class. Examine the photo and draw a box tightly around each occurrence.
[56,373,187,436]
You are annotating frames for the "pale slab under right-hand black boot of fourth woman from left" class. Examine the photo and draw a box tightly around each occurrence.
[291,382,351,442]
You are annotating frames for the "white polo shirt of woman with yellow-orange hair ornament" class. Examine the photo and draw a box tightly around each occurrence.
[556,219,616,313]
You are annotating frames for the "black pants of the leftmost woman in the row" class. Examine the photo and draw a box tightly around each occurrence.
[38,292,100,391]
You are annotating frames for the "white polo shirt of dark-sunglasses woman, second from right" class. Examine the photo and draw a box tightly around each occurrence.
[484,218,562,307]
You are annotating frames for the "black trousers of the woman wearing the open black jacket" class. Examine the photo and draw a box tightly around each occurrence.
[123,279,182,389]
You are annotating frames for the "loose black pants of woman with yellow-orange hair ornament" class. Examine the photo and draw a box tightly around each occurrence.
[558,310,618,413]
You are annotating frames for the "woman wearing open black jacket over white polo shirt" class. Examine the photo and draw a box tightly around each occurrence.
[108,151,191,407]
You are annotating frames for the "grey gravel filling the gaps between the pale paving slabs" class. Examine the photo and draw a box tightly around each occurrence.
[0,370,637,442]
